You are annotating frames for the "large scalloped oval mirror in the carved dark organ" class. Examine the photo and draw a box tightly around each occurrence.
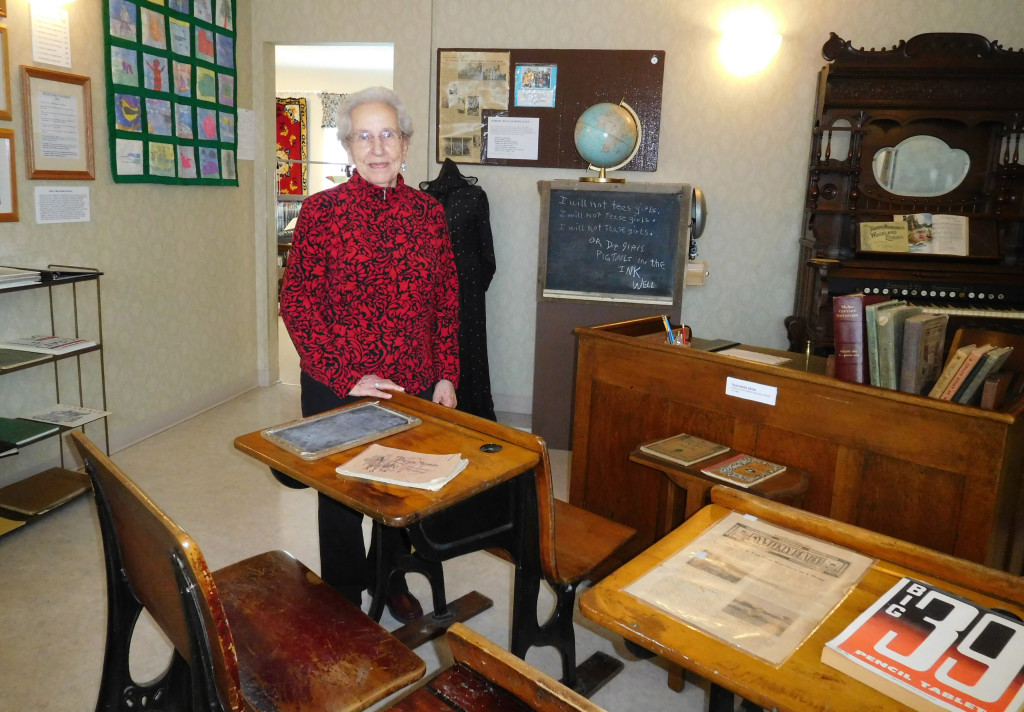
[871,136,971,198]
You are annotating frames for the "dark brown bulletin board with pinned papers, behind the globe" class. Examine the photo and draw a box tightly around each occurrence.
[436,48,665,172]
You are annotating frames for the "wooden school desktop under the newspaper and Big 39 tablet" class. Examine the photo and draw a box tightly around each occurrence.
[580,486,1024,712]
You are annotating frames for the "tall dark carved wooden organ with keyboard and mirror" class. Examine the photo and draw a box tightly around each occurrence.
[785,33,1024,354]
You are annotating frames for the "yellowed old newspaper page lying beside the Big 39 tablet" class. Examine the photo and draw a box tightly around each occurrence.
[625,512,872,665]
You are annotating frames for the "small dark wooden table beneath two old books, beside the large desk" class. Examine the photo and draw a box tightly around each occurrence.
[630,441,811,538]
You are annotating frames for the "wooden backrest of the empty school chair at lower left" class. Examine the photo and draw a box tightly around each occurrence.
[71,431,244,710]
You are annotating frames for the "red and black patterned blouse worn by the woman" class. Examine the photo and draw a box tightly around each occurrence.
[281,173,459,396]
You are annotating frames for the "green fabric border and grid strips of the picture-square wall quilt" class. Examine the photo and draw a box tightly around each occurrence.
[102,0,239,186]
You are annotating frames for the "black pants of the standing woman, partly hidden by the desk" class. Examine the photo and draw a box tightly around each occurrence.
[270,372,433,605]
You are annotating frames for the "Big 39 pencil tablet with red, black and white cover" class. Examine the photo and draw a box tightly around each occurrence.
[821,578,1024,712]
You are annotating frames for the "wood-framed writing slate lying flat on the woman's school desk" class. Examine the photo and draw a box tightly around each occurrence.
[268,402,422,460]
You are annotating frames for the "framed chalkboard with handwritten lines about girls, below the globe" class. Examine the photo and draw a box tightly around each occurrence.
[538,180,691,304]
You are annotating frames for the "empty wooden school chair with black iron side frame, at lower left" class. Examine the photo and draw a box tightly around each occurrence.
[72,431,426,712]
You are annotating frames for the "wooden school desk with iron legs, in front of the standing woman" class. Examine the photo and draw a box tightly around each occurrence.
[234,394,540,647]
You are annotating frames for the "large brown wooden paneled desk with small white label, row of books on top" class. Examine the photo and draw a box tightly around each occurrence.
[569,318,1024,575]
